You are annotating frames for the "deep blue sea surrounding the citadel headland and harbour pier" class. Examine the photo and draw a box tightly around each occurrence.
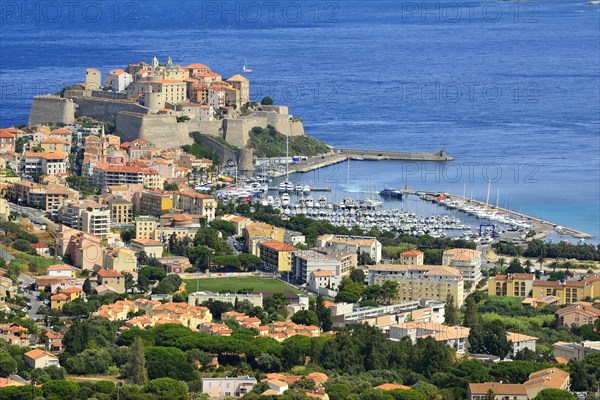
[0,0,600,241]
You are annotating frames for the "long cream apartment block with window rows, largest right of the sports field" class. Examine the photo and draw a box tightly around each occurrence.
[367,264,464,307]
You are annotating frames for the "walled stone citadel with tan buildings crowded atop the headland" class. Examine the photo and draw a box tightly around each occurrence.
[28,57,304,164]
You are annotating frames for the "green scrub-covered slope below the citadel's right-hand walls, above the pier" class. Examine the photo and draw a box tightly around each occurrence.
[250,125,329,157]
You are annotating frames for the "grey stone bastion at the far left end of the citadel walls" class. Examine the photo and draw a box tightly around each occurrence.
[27,96,76,125]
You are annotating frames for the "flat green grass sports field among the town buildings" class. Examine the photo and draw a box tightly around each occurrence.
[184,276,302,293]
